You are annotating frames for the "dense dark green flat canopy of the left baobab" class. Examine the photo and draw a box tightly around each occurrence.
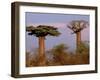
[26,25,61,37]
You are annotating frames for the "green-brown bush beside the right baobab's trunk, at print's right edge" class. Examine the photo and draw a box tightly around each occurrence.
[76,42,89,64]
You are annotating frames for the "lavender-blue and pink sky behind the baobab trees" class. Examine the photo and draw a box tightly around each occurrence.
[25,12,89,52]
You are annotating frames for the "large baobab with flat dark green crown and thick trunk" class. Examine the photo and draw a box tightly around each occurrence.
[26,25,60,66]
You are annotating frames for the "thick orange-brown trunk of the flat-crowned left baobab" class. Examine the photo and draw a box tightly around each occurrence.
[38,37,46,66]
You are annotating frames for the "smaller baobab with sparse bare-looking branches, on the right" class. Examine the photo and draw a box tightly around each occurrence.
[68,20,88,49]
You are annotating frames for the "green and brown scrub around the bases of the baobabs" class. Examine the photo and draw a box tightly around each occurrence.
[26,42,89,67]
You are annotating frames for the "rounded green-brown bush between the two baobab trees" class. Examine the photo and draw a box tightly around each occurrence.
[51,43,68,65]
